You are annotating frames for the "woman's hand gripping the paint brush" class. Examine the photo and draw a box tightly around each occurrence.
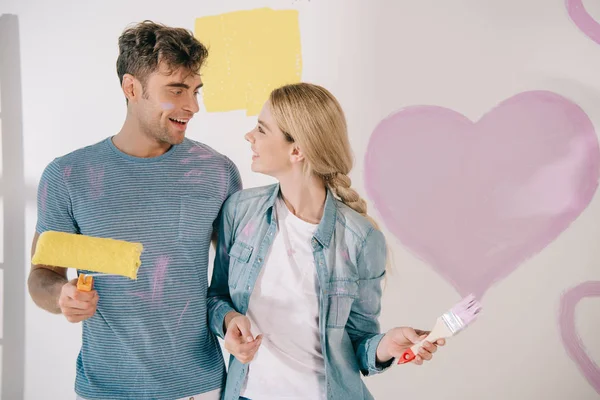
[377,327,446,365]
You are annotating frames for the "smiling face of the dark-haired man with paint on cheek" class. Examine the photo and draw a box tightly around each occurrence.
[135,64,202,145]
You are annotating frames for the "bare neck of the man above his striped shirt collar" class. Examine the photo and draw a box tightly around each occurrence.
[112,118,171,158]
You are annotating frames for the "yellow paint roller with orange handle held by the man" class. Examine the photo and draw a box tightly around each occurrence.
[31,231,144,292]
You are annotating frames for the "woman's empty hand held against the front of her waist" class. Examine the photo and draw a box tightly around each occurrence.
[224,313,262,364]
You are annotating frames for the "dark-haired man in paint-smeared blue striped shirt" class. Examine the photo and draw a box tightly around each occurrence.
[28,21,241,400]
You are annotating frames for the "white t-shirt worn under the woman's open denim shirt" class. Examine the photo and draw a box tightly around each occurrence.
[241,198,326,400]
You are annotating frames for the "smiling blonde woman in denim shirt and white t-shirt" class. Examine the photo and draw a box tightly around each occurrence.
[208,83,444,400]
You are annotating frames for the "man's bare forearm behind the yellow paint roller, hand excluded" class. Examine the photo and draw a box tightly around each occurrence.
[27,232,68,314]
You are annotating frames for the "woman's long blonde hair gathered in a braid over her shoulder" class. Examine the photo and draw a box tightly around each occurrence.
[269,83,379,229]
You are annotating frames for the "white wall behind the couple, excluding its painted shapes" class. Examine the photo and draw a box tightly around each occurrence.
[0,0,600,400]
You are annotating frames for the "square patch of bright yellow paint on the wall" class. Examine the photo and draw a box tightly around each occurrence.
[195,8,302,115]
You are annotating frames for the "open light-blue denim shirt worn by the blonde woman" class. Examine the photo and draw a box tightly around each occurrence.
[208,184,393,400]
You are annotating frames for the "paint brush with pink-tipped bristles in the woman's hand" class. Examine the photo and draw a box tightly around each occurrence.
[398,294,481,364]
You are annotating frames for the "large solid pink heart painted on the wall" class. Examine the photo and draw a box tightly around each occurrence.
[365,91,600,296]
